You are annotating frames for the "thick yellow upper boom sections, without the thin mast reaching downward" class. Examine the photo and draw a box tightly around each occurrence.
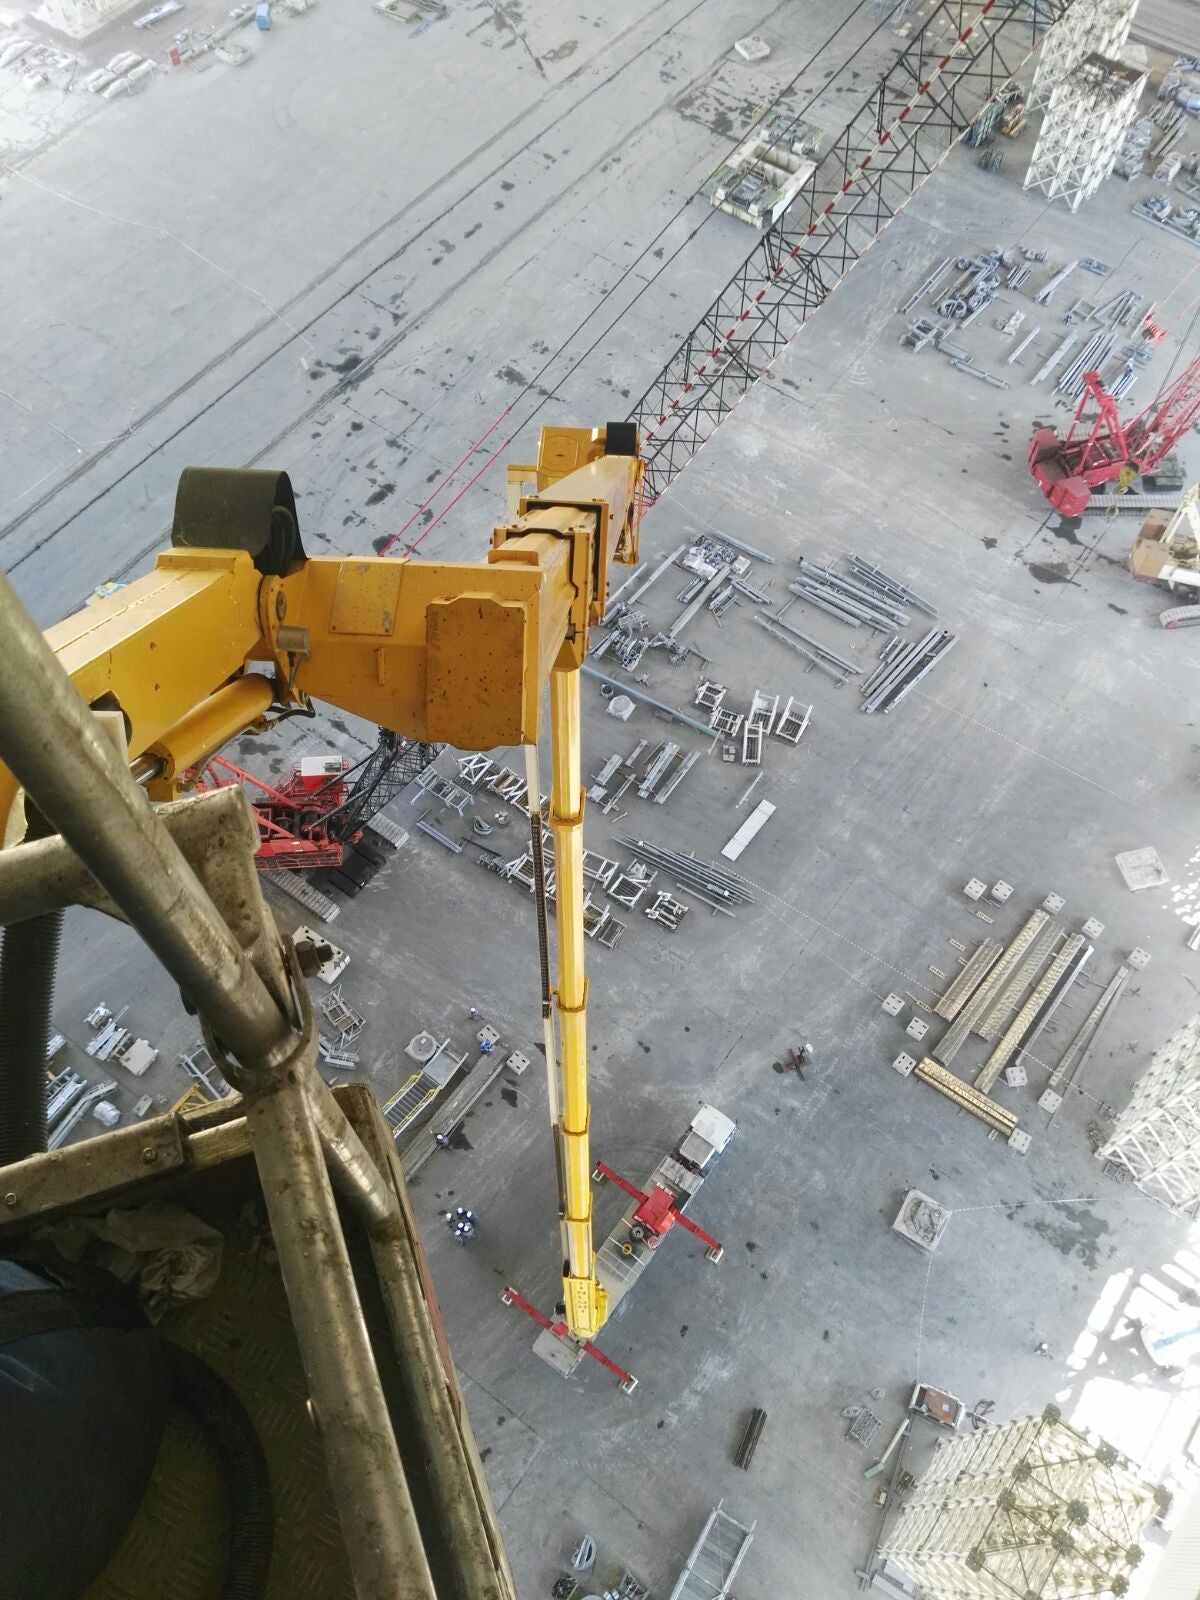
[0,429,642,819]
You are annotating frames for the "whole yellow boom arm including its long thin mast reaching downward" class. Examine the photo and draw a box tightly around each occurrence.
[0,424,643,1339]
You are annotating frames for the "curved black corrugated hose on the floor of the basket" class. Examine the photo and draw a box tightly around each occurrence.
[163,1341,275,1600]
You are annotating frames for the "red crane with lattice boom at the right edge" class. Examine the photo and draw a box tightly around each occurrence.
[1029,358,1200,517]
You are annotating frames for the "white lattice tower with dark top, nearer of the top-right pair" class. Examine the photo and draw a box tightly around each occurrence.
[1024,53,1146,211]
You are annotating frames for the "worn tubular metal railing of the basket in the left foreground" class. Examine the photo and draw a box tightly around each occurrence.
[0,576,512,1600]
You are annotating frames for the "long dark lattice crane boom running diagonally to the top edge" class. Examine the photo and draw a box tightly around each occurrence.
[630,0,1080,504]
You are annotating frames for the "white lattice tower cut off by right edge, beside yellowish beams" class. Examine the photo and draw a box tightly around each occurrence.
[1096,1016,1200,1218]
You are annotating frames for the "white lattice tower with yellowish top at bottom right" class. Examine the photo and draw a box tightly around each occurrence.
[880,1406,1166,1600]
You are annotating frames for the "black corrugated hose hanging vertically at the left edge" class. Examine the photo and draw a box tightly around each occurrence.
[0,910,62,1166]
